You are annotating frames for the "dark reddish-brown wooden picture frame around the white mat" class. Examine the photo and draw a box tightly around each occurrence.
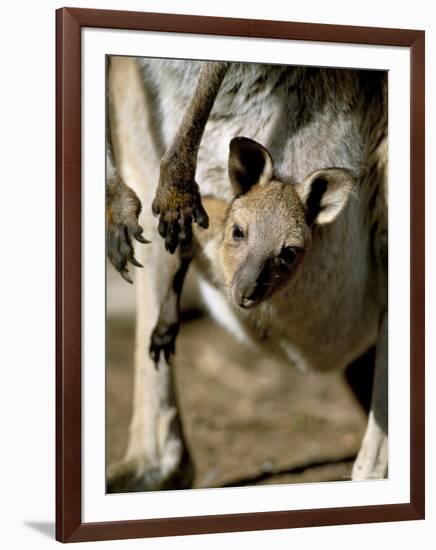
[56,8,425,542]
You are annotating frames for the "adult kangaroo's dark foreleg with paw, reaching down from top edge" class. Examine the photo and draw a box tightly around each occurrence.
[153,62,229,253]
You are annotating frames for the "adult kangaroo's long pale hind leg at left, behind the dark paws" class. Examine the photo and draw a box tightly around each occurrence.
[107,59,193,492]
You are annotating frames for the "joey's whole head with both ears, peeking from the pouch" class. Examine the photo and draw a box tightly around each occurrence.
[219,137,353,308]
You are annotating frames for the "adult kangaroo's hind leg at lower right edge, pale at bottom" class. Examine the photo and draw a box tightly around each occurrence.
[352,313,388,480]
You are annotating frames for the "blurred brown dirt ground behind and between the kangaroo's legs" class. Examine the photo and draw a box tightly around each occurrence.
[106,266,366,487]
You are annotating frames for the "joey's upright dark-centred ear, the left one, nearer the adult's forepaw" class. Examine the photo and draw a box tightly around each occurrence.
[229,137,273,195]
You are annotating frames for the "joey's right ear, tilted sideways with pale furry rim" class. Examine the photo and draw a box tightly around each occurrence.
[296,168,355,225]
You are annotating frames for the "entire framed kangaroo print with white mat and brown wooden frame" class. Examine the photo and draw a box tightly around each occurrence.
[56,8,425,542]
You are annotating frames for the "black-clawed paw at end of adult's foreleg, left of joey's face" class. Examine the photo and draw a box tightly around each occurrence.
[152,177,209,254]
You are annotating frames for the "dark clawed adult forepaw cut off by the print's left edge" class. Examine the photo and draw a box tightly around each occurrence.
[106,180,150,283]
